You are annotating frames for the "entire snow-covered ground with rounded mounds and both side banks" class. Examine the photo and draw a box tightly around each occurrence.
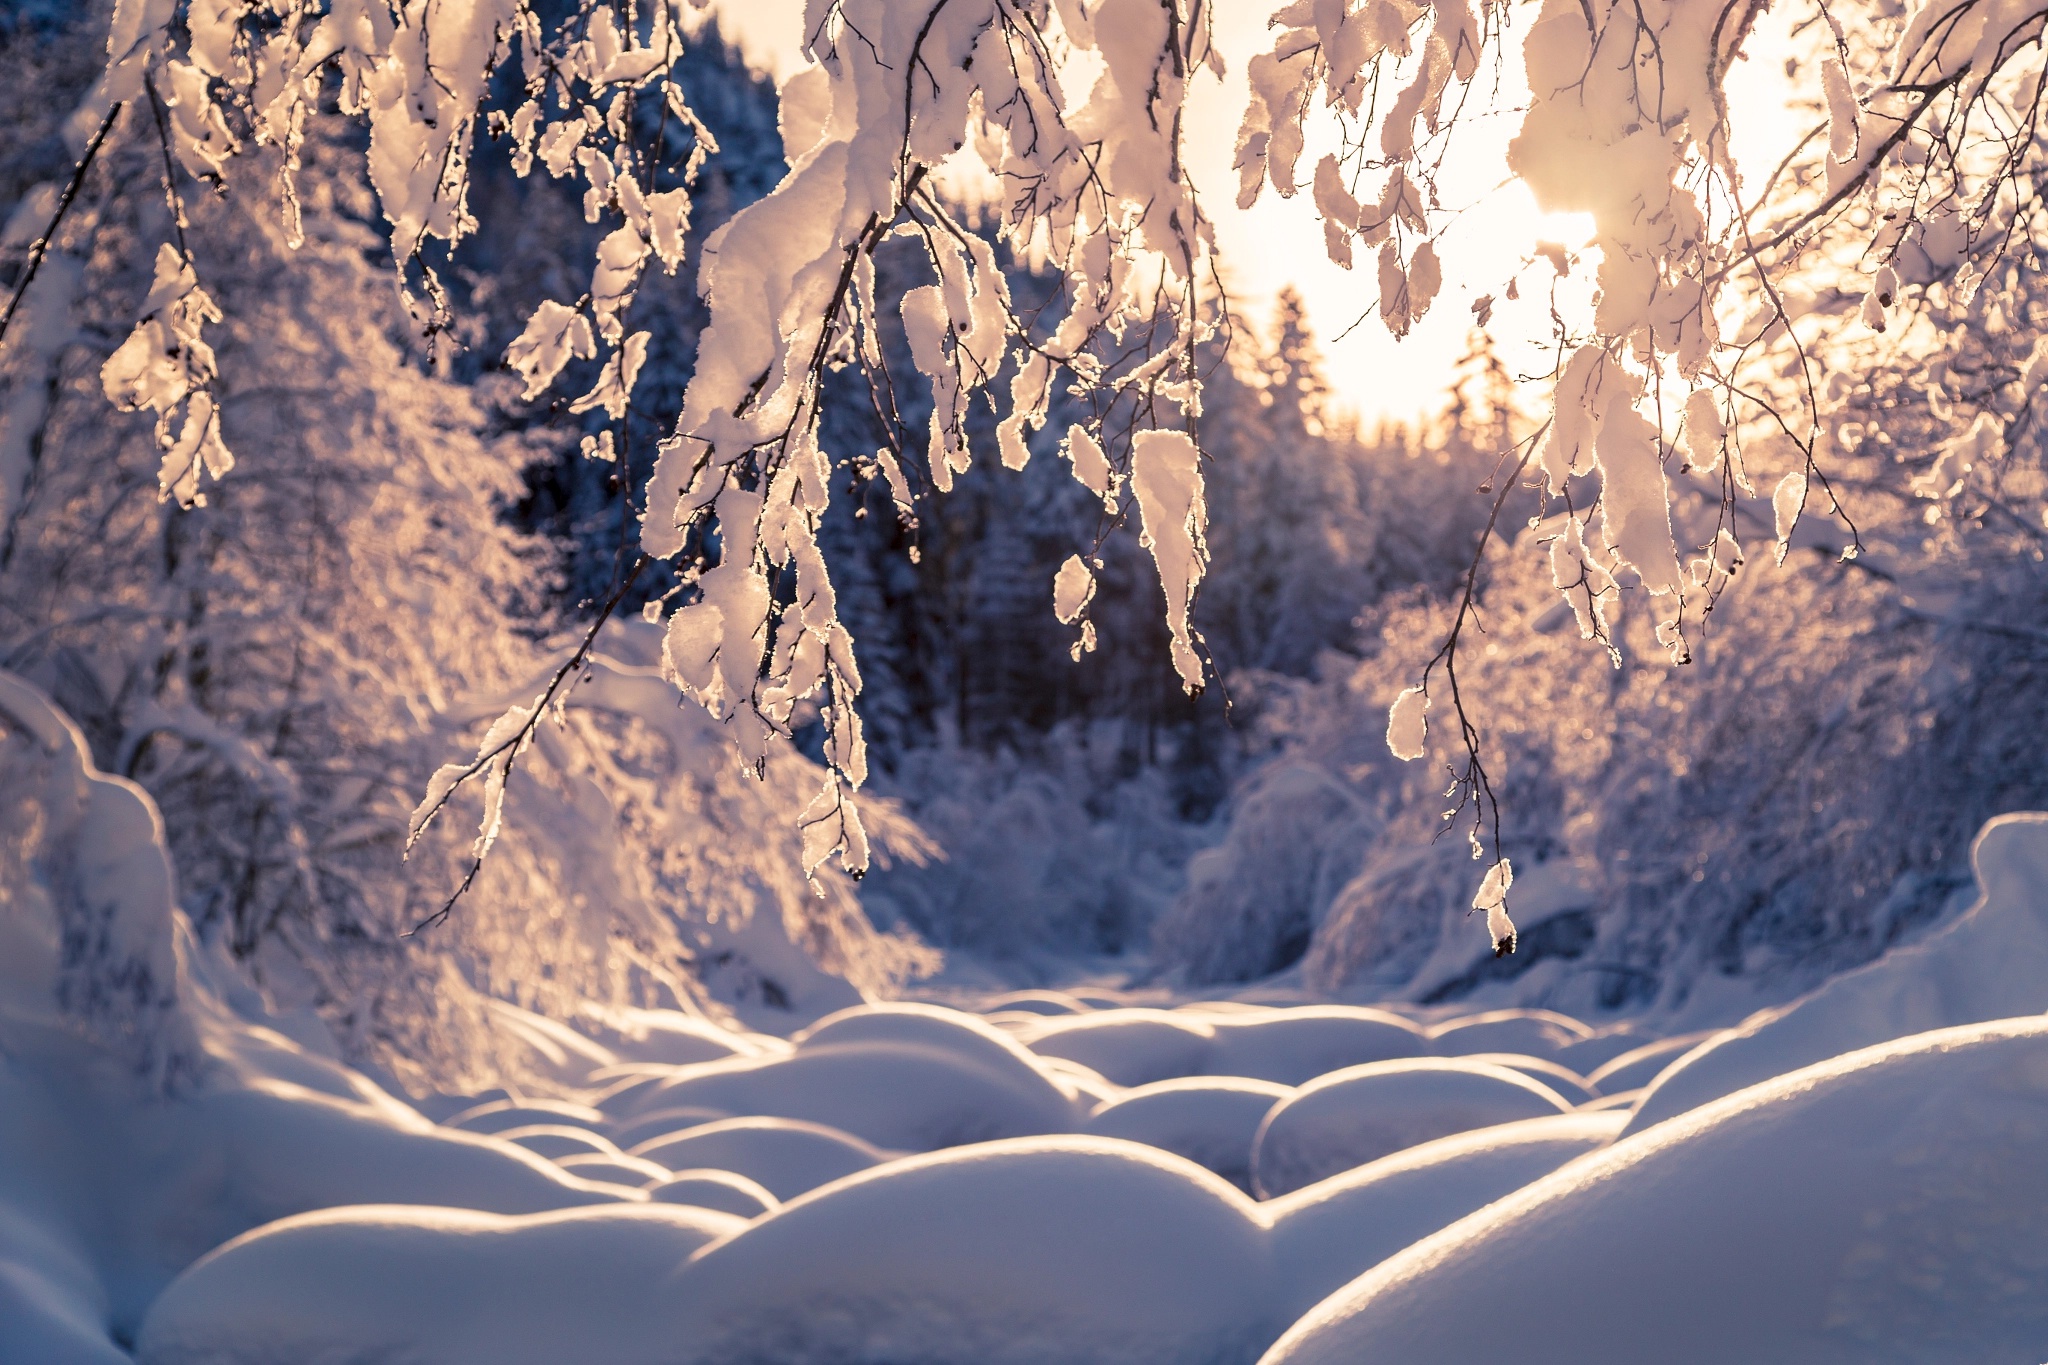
[12,675,2048,1365]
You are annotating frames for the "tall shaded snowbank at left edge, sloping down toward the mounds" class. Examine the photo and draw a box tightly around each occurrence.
[0,673,639,1365]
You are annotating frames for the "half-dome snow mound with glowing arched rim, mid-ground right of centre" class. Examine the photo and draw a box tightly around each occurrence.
[1251,1058,1571,1199]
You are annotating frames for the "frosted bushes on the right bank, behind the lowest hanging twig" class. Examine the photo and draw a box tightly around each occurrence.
[1159,462,2048,1011]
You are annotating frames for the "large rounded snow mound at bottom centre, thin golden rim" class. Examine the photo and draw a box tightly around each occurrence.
[662,1138,1278,1365]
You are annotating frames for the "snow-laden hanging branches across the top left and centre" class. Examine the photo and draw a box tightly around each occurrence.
[51,0,1210,896]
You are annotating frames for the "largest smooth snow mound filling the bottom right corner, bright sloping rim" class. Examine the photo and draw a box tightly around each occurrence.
[1264,1017,2048,1365]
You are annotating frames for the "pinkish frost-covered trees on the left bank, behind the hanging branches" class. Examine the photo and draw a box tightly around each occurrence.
[0,24,930,1085]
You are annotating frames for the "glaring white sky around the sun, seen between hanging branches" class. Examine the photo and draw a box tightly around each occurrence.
[713,0,1782,424]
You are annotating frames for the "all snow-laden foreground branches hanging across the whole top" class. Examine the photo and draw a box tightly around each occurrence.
[20,0,2042,950]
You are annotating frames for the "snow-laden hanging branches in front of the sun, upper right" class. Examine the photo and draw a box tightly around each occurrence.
[1212,0,2042,943]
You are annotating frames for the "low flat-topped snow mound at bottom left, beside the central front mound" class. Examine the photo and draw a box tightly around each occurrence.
[135,1203,745,1365]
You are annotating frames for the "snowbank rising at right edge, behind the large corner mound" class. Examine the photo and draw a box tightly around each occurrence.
[1628,812,2048,1134]
